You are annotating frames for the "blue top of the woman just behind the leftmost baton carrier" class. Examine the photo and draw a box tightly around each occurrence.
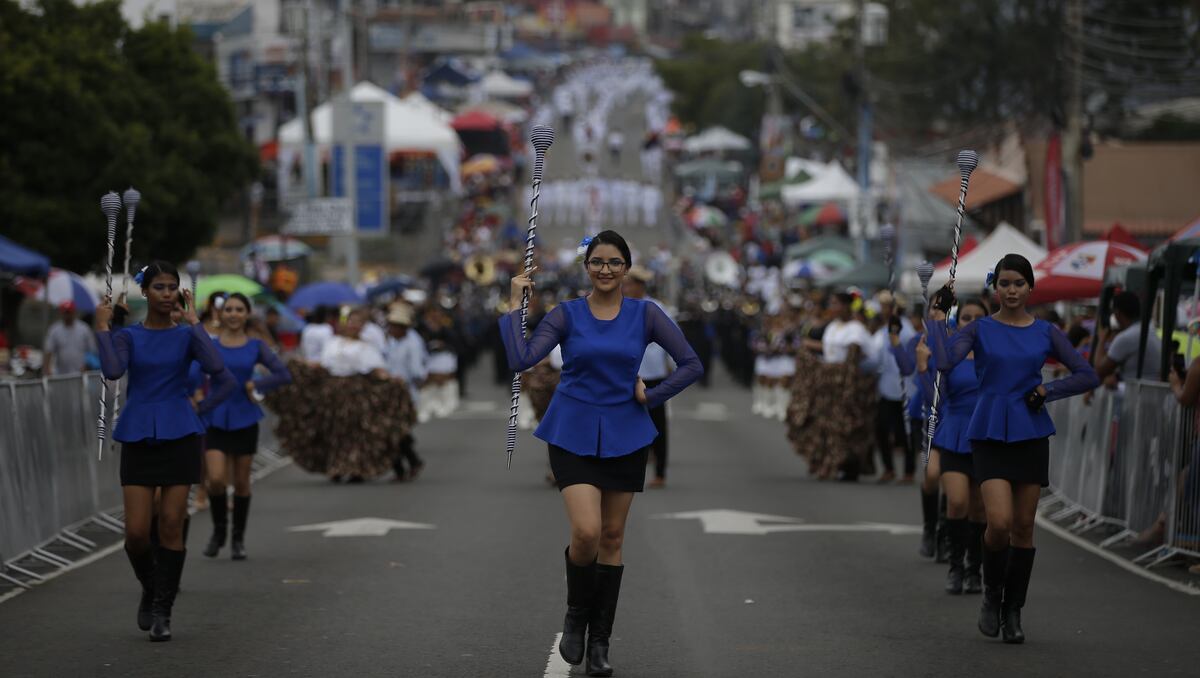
[188,338,292,431]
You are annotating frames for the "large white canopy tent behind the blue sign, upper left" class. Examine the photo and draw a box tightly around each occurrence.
[280,83,462,191]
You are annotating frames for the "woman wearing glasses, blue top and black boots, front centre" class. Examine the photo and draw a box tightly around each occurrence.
[499,230,703,676]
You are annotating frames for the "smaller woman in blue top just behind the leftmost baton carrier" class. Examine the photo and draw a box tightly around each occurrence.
[193,292,292,560]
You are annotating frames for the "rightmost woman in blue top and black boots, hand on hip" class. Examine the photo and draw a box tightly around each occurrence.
[925,254,1099,643]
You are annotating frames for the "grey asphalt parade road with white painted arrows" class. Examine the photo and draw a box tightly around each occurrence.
[0,372,1200,678]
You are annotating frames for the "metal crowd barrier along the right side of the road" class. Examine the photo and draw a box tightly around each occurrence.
[1044,379,1200,566]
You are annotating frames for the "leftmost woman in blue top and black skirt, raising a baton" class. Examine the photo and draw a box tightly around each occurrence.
[96,262,234,641]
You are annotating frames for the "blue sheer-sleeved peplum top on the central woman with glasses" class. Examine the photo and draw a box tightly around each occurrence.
[499,298,704,457]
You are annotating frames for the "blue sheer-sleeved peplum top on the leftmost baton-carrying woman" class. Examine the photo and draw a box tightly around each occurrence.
[96,323,235,443]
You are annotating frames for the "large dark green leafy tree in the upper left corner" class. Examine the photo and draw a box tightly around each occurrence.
[0,0,257,270]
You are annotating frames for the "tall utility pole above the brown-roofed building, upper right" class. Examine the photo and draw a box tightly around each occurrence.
[1062,0,1084,242]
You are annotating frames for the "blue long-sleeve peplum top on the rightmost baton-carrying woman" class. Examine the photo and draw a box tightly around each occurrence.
[925,316,1100,443]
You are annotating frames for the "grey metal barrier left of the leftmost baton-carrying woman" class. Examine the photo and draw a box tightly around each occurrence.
[0,372,121,563]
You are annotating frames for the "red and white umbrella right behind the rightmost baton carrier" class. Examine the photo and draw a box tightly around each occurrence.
[1028,240,1146,304]
